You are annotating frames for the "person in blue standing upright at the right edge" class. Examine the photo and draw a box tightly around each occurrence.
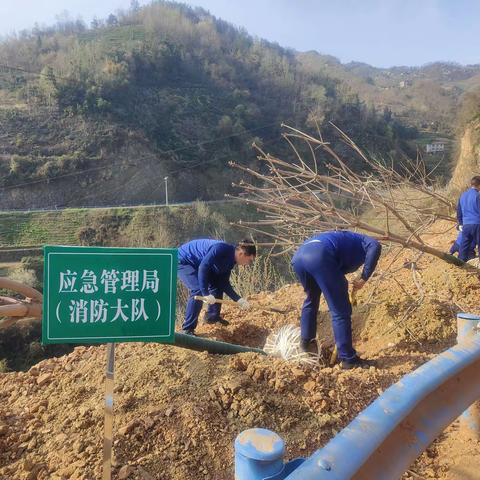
[457,176,480,262]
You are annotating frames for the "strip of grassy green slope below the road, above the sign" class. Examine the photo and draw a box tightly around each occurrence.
[0,202,256,248]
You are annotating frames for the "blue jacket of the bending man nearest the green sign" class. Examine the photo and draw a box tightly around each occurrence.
[178,238,240,301]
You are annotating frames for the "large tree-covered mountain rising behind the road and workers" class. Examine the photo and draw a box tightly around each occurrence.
[0,1,464,208]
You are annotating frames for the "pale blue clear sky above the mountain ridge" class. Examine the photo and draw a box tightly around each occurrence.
[0,0,480,67]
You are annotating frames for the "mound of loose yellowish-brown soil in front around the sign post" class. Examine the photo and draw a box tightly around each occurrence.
[0,344,412,480]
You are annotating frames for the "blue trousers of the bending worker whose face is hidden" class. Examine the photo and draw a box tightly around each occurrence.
[292,242,356,360]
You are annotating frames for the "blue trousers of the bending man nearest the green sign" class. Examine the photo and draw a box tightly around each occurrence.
[177,264,223,330]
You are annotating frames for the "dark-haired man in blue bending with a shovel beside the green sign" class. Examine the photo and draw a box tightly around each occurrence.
[178,239,257,335]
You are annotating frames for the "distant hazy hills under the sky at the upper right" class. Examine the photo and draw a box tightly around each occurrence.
[297,52,480,136]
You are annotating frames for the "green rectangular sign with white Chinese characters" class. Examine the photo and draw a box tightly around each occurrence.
[42,246,177,343]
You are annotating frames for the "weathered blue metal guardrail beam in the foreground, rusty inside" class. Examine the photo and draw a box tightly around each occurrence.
[285,336,480,480]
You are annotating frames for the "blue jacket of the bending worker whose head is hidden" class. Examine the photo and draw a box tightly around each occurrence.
[303,231,382,280]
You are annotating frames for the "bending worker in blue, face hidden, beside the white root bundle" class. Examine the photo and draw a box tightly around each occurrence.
[292,231,382,369]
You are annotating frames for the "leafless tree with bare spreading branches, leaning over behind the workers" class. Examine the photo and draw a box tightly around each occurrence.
[231,125,472,271]
